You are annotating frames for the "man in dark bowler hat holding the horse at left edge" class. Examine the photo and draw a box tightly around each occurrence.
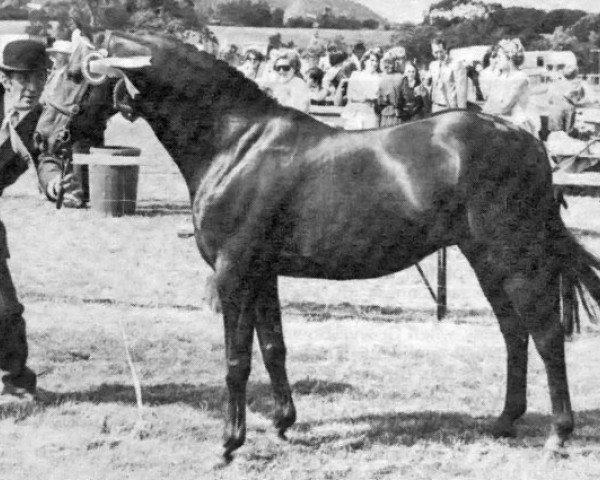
[0,40,72,407]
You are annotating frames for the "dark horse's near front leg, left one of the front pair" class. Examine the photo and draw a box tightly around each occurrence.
[217,268,256,461]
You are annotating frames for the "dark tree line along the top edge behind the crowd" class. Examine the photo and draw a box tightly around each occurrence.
[7,0,600,72]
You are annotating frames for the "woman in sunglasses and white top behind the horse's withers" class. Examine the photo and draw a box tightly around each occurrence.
[265,49,310,112]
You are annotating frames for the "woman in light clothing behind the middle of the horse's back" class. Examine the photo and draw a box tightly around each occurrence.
[341,50,381,130]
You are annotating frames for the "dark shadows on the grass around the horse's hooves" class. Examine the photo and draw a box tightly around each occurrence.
[25,379,600,449]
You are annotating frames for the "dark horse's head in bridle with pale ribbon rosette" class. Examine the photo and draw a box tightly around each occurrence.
[34,33,152,155]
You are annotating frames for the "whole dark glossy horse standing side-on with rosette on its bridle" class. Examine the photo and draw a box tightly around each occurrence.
[37,32,600,458]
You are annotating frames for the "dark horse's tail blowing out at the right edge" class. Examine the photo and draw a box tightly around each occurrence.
[559,222,600,336]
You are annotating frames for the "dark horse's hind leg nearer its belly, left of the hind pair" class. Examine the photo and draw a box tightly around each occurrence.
[461,245,529,437]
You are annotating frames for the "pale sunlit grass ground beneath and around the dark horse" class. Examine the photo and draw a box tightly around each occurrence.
[0,114,600,480]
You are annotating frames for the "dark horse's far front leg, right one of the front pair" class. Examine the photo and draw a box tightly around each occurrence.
[256,275,296,438]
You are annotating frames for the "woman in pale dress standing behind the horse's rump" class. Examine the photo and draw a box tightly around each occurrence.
[482,38,539,136]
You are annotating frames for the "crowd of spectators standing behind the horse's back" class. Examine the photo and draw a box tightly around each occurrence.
[221,34,583,135]
